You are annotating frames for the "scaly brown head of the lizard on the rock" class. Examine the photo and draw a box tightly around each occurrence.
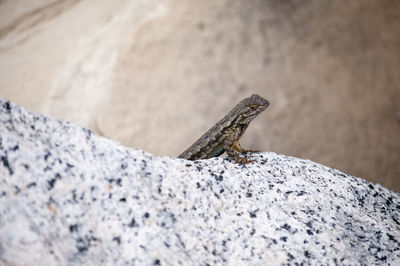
[234,94,269,124]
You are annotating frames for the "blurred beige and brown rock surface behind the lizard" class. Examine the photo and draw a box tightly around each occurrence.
[0,0,400,191]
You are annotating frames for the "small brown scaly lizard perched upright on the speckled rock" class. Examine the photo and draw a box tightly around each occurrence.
[178,94,269,163]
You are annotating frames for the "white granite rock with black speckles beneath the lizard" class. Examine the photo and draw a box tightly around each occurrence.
[0,98,400,265]
